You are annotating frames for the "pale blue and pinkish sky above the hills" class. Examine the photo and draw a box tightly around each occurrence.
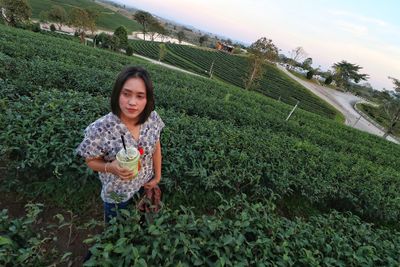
[115,0,400,90]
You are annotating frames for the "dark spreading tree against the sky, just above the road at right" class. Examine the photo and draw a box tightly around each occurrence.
[332,60,369,90]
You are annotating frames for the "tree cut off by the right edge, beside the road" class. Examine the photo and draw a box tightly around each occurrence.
[383,77,400,138]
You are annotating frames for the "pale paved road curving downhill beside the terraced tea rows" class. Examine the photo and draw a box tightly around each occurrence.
[278,65,399,144]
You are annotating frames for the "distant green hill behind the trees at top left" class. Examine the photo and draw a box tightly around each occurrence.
[28,0,141,32]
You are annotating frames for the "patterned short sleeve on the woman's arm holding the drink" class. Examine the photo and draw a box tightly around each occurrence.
[76,123,105,159]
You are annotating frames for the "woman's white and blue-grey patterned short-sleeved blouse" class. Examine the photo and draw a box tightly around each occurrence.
[76,111,164,203]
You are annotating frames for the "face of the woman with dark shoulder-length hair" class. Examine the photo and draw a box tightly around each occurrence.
[119,78,147,123]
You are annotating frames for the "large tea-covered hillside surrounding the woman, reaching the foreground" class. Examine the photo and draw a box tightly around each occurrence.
[0,25,400,266]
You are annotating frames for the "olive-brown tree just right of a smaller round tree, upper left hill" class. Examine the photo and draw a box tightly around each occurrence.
[69,7,96,43]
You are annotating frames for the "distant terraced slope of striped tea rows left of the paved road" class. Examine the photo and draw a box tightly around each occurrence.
[130,40,341,121]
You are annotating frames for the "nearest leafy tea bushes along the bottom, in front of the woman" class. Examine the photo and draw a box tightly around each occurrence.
[85,196,400,266]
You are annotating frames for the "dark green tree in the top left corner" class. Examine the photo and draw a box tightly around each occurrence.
[0,0,32,27]
